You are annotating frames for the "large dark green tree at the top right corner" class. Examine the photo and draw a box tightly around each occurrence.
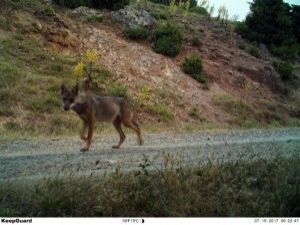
[236,0,300,61]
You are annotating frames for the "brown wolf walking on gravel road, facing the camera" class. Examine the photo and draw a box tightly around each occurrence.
[61,84,143,152]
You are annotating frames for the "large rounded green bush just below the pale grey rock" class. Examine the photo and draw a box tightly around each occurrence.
[154,23,183,57]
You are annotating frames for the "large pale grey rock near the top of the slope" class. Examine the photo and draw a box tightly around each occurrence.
[112,6,156,28]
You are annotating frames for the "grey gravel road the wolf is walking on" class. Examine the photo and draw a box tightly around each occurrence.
[0,128,300,181]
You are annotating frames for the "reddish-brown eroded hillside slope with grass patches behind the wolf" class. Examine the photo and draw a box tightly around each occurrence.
[0,0,300,134]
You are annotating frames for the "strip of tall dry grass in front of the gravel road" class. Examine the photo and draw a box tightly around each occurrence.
[0,155,300,217]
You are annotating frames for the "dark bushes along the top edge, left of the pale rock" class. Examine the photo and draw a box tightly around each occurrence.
[54,0,129,10]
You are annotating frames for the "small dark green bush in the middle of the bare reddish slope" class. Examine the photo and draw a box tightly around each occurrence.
[181,56,207,83]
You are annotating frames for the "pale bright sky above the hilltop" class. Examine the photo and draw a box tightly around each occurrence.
[204,0,300,21]
